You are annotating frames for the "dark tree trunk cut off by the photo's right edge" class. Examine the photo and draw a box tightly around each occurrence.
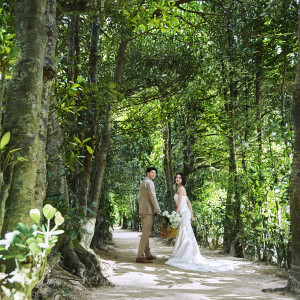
[288,3,300,294]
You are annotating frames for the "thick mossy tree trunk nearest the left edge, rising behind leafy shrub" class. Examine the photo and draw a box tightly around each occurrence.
[2,0,47,234]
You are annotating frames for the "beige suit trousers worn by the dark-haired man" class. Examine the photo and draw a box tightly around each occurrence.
[137,214,154,258]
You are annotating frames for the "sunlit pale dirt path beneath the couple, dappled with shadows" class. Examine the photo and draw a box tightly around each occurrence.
[80,228,298,300]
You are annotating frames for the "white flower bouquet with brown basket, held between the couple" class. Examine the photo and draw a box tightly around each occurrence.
[159,211,181,238]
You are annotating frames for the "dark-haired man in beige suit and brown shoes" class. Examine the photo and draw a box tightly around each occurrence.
[136,167,161,263]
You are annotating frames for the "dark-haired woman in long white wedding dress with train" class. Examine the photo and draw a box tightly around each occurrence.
[166,173,236,272]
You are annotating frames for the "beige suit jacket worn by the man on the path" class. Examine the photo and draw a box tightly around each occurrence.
[139,176,160,215]
